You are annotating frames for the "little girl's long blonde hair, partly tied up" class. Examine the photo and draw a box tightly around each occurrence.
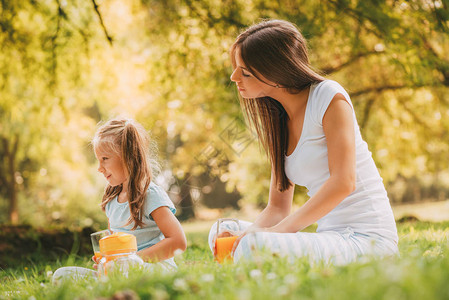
[92,118,157,230]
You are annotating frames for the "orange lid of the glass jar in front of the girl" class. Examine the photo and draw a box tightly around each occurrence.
[100,232,137,255]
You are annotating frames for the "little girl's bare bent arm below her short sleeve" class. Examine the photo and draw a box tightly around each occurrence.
[137,206,187,262]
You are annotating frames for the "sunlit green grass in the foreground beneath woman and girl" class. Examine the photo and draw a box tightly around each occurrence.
[0,222,449,300]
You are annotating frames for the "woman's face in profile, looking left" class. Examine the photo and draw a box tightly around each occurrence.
[231,49,275,98]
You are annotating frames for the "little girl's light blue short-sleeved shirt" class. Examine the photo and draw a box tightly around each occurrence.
[105,182,176,265]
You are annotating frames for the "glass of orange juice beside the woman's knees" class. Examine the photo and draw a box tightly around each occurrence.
[215,218,240,263]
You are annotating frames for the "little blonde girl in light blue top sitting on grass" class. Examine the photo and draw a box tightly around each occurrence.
[53,119,186,280]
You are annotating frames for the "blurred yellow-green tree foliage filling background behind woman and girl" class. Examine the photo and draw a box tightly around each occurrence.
[0,0,449,227]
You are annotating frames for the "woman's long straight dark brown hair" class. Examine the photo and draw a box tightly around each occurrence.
[230,20,324,192]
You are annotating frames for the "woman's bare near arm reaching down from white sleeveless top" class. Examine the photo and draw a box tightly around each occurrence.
[267,94,356,232]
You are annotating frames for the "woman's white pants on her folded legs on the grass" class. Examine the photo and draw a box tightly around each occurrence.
[209,221,398,265]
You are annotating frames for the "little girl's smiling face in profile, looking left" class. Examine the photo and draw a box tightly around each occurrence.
[95,146,128,186]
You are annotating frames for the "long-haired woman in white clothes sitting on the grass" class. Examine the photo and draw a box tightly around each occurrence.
[209,20,398,264]
